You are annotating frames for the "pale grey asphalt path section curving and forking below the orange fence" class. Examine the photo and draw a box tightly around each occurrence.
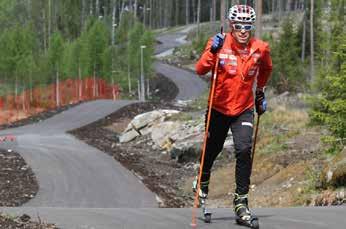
[0,100,157,208]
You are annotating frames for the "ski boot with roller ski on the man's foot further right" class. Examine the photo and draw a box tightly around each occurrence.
[233,193,259,229]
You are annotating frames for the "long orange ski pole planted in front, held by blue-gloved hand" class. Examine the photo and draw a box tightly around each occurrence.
[191,26,223,227]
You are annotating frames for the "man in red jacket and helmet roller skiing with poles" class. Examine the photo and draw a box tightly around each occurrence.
[193,5,272,228]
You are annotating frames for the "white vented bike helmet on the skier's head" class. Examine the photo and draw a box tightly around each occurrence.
[228,5,256,24]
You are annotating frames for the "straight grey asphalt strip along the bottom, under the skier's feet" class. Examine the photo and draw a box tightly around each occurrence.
[1,207,346,229]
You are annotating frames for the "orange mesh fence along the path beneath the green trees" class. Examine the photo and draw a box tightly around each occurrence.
[0,77,120,124]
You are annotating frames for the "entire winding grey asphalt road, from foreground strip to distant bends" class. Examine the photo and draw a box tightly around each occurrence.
[0,25,346,229]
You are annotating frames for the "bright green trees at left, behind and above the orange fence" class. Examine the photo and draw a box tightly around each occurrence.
[0,0,154,96]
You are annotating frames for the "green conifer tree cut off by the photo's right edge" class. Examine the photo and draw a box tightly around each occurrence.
[310,0,346,152]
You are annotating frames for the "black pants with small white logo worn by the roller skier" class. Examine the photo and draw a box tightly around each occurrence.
[201,109,254,195]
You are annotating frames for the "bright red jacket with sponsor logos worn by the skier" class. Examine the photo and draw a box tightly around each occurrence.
[196,33,272,116]
